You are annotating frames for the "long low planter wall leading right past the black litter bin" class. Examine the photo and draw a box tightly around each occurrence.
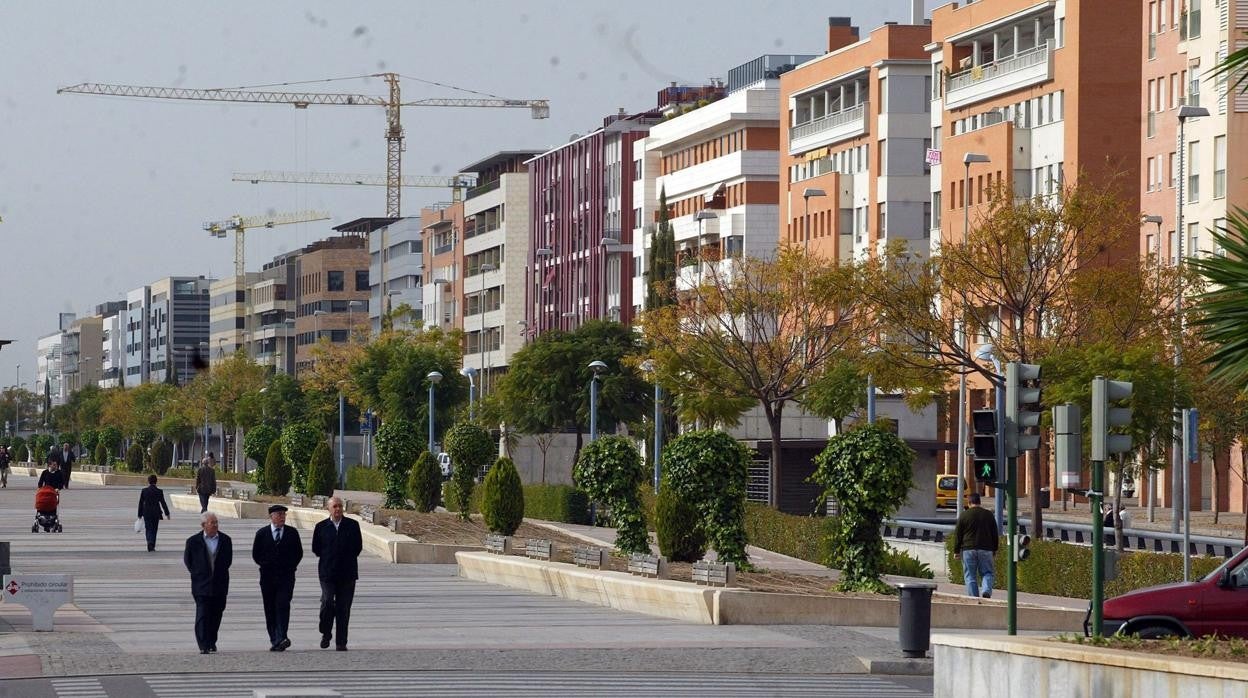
[456,553,1083,632]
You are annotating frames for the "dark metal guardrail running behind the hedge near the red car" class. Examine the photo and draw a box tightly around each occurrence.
[884,518,1244,557]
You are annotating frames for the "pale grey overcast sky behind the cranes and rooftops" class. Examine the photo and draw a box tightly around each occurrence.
[0,0,943,388]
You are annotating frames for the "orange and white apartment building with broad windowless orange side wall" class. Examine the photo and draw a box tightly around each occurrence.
[929,0,1144,497]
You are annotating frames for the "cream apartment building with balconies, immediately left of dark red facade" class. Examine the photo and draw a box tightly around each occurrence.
[459,150,540,395]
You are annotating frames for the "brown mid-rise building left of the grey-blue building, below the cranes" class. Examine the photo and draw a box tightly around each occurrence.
[295,233,371,375]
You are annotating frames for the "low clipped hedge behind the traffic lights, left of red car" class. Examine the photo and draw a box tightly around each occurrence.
[945,537,1223,598]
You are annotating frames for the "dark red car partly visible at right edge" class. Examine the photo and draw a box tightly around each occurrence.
[1085,548,1248,639]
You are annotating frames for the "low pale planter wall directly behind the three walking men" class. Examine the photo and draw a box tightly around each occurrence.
[168,494,483,564]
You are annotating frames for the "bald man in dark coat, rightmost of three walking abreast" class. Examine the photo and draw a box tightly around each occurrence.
[312,497,364,652]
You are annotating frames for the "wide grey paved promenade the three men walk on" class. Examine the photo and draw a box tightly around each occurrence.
[0,477,931,697]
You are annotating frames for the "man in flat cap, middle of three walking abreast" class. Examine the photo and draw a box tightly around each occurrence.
[251,504,303,652]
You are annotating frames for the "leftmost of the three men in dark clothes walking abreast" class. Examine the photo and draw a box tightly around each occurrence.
[182,512,233,654]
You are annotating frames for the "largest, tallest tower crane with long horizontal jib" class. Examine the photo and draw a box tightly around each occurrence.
[56,72,550,219]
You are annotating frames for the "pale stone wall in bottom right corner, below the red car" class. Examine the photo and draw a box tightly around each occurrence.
[932,634,1248,698]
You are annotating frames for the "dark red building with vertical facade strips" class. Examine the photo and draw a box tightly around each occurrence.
[524,107,663,336]
